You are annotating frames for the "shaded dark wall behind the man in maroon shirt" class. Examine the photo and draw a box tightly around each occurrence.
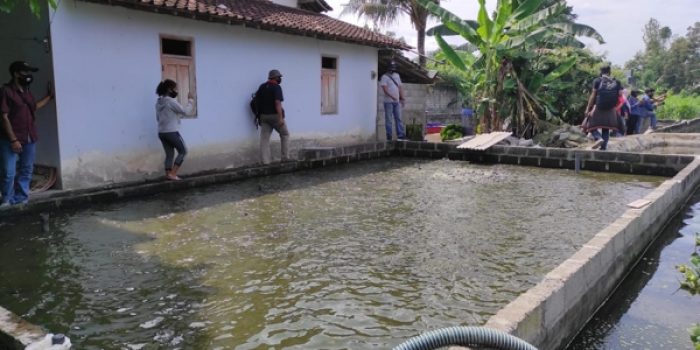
[0,1,59,172]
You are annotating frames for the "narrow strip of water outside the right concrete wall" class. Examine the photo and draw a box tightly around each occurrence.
[569,192,700,350]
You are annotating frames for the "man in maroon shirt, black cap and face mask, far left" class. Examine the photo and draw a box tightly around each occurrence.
[0,61,53,206]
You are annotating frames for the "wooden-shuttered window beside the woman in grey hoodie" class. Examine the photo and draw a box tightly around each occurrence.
[160,36,197,112]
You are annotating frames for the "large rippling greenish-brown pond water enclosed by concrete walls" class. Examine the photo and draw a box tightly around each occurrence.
[0,158,664,350]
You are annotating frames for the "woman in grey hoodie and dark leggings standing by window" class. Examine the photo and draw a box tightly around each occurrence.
[156,79,195,180]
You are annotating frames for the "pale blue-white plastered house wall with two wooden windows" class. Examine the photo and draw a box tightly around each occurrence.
[52,0,377,188]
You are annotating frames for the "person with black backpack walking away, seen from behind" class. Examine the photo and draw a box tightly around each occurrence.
[585,66,622,150]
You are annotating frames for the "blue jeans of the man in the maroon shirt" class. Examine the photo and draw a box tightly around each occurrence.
[0,139,36,204]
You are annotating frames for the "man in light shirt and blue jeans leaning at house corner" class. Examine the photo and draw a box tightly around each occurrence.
[379,61,406,141]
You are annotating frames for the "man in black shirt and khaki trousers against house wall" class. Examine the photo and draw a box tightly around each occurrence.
[256,69,289,164]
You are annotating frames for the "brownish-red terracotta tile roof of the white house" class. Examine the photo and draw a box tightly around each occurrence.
[77,0,410,49]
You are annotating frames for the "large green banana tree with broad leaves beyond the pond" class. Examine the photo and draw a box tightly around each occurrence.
[416,0,603,135]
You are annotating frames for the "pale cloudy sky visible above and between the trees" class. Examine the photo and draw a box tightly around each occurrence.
[326,0,700,65]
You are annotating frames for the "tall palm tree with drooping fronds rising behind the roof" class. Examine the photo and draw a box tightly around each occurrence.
[341,0,440,67]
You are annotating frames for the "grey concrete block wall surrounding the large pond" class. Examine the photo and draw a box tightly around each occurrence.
[0,141,700,349]
